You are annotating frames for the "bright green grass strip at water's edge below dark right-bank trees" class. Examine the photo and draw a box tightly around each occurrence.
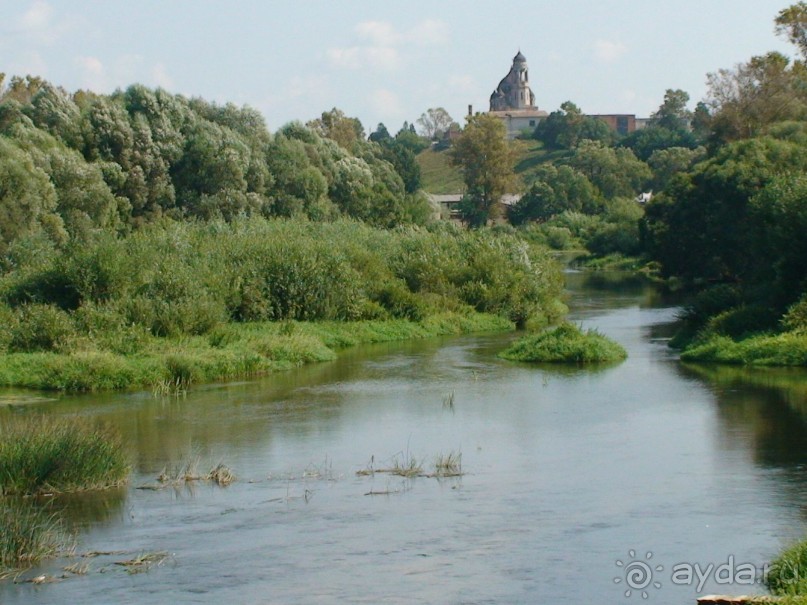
[681,332,807,366]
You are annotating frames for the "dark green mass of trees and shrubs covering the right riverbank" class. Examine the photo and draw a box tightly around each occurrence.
[642,3,807,365]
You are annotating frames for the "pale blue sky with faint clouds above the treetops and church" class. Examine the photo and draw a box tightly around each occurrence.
[0,0,796,133]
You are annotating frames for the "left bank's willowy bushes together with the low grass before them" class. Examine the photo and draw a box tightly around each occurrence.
[0,218,565,391]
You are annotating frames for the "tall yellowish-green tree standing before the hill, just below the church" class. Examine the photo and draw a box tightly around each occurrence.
[450,114,515,227]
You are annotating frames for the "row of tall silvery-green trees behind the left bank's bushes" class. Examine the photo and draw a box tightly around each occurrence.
[0,77,431,252]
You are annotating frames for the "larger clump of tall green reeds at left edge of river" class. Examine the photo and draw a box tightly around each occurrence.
[0,415,129,496]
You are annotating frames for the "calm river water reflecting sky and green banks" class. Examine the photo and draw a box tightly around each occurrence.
[0,273,807,604]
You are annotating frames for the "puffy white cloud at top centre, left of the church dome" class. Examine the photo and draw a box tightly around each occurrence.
[326,19,448,71]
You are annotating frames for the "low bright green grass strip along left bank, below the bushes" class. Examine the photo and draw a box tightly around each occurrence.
[0,313,515,394]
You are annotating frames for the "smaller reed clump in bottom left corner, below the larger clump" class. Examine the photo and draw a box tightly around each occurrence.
[0,498,72,579]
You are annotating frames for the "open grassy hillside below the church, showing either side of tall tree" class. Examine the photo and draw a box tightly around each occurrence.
[417,141,565,194]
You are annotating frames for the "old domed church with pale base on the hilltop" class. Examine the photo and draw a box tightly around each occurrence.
[489,50,547,139]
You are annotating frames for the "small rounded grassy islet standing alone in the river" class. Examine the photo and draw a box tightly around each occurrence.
[499,322,627,363]
